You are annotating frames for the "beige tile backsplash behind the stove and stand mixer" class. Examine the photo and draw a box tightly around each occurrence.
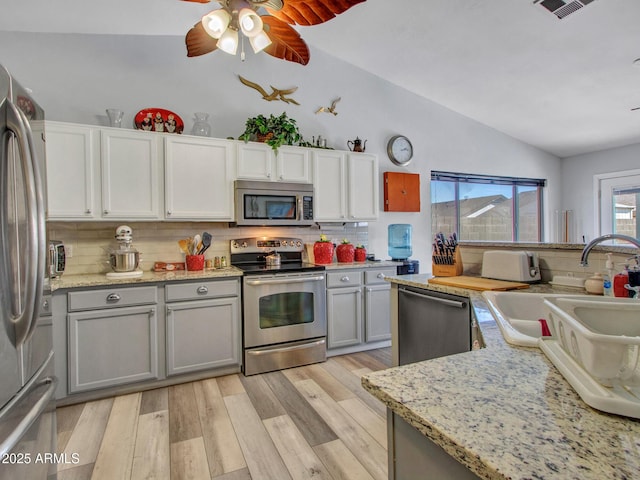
[47,222,369,275]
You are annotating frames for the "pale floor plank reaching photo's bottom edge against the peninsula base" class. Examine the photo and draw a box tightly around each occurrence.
[295,380,387,480]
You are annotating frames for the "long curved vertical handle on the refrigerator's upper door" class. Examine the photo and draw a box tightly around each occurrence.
[3,98,45,347]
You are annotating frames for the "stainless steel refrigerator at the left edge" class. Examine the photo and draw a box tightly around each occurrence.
[0,65,60,480]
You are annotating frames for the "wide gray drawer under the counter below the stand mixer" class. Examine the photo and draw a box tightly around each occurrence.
[68,286,158,312]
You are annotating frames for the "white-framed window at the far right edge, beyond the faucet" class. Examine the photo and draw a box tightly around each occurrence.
[594,170,640,243]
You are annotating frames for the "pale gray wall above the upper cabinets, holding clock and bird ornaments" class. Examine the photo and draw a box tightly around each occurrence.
[0,32,561,272]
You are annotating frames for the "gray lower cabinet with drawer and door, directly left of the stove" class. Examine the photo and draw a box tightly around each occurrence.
[165,279,241,376]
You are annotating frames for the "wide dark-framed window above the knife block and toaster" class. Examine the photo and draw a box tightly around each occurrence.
[431,171,546,242]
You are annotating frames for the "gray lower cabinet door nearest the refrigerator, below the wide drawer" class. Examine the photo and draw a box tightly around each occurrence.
[68,306,158,393]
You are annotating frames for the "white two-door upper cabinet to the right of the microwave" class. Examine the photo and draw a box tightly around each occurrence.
[313,150,379,222]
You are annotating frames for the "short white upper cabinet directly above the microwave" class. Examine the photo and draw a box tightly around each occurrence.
[237,142,311,183]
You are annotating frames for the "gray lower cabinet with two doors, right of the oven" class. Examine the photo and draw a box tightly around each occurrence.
[327,267,396,349]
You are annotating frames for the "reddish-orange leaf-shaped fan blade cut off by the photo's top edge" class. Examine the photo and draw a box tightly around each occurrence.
[265,0,366,26]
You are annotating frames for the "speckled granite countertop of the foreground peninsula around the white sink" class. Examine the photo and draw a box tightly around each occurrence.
[362,275,640,480]
